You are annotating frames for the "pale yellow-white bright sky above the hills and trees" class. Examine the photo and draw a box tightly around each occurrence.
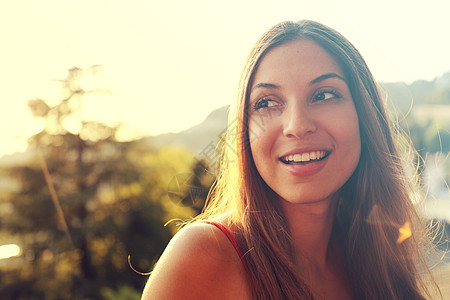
[0,0,450,156]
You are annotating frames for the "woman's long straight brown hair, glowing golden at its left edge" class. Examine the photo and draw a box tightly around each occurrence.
[192,21,440,299]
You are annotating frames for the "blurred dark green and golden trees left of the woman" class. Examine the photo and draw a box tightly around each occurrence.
[0,66,202,299]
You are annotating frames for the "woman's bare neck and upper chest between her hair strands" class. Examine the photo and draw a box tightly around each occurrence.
[282,197,353,299]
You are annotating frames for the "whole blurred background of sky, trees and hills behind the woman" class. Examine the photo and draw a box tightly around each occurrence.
[0,0,450,299]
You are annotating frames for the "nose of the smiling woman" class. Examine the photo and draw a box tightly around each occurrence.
[282,105,317,138]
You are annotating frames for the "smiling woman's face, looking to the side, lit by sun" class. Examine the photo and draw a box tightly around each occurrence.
[248,40,361,203]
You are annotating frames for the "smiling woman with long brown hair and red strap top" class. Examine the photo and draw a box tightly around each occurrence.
[143,21,442,299]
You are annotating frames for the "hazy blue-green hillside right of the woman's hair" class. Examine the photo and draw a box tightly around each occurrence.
[381,73,450,182]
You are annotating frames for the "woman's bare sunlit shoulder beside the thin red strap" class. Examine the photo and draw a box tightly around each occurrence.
[142,223,250,300]
